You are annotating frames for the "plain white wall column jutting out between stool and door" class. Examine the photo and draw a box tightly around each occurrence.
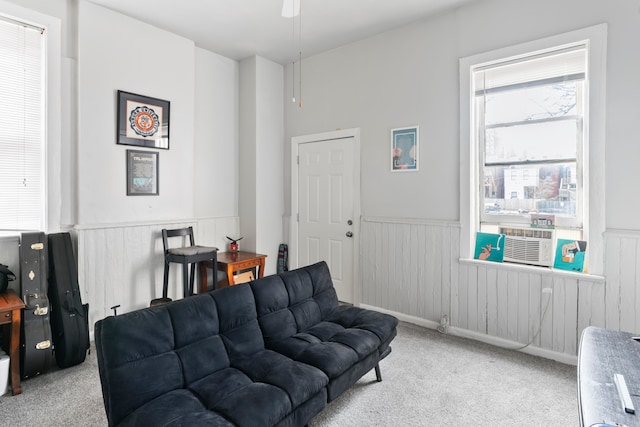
[238,56,284,274]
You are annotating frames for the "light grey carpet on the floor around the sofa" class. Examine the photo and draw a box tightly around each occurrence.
[0,323,578,427]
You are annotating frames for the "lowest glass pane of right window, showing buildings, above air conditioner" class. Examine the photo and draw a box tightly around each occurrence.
[484,162,577,216]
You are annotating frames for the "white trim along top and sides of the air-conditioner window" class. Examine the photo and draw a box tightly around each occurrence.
[459,24,607,275]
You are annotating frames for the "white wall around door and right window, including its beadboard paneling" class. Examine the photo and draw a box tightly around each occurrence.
[284,0,640,360]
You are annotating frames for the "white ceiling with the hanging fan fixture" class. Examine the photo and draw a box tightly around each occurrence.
[90,0,479,64]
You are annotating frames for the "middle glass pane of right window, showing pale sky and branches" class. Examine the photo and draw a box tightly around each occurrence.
[485,118,578,165]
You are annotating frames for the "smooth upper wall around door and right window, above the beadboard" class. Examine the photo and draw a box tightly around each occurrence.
[285,0,640,229]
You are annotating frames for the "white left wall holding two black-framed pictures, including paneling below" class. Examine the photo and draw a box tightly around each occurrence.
[0,0,239,328]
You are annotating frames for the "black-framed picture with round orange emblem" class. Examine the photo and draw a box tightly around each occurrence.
[117,90,170,150]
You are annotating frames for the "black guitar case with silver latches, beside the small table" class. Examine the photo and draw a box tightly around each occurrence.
[19,232,53,379]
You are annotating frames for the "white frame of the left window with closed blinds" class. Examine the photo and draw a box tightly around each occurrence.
[0,0,62,237]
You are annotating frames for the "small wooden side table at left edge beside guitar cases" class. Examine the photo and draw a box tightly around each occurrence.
[0,291,24,396]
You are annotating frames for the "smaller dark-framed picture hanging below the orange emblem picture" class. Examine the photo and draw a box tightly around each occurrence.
[127,150,160,196]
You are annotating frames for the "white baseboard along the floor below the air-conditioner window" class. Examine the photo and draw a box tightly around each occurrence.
[359,304,578,366]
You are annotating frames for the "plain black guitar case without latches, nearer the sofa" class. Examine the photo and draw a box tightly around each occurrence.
[49,233,89,368]
